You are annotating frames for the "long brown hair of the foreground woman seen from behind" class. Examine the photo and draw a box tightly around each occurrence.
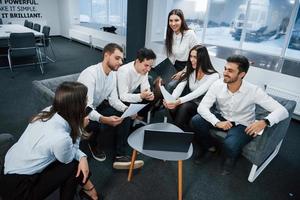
[31,82,88,143]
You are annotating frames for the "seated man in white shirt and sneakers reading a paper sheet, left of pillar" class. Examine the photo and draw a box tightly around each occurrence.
[78,43,144,169]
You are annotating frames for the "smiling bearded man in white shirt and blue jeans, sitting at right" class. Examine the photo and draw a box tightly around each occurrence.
[192,55,288,175]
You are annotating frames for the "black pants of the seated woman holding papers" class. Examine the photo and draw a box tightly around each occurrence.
[169,101,198,131]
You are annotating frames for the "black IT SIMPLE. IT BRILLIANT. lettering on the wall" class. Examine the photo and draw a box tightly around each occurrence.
[0,0,42,22]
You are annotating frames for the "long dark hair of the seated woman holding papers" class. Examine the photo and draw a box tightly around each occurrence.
[181,45,218,80]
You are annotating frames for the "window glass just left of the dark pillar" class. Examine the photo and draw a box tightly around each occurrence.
[80,0,127,35]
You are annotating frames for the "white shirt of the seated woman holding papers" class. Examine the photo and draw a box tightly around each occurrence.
[172,71,219,103]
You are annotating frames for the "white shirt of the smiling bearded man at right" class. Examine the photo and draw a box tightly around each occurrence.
[198,79,289,126]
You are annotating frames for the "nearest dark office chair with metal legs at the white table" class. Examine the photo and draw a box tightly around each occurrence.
[7,33,44,74]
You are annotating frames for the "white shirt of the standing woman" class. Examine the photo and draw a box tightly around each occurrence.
[169,30,199,64]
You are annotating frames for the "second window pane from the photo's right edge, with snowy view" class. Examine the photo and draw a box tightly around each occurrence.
[242,0,295,56]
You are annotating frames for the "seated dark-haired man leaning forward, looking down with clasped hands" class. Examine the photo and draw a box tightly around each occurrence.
[117,48,156,119]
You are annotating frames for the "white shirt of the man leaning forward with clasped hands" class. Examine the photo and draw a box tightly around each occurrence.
[117,61,150,103]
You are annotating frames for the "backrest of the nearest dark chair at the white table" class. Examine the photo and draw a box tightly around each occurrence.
[9,33,36,57]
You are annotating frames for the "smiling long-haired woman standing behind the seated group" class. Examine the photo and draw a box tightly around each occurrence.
[165,9,198,83]
